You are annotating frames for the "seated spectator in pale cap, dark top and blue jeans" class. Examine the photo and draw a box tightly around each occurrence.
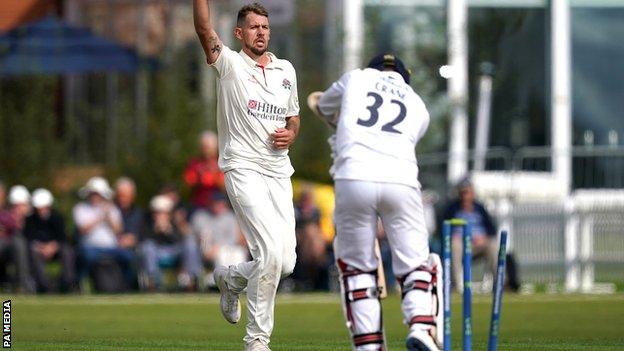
[141,195,201,290]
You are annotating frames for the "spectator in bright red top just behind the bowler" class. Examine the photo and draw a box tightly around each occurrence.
[184,131,224,208]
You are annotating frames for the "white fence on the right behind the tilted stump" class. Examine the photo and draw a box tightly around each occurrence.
[495,195,624,292]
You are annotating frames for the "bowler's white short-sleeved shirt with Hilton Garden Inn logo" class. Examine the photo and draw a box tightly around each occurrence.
[212,46,299,178]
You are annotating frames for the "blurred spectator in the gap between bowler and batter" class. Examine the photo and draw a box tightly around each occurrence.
[294,188,328,290]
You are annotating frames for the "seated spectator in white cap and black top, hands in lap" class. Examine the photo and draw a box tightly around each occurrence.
[24,189,75,292]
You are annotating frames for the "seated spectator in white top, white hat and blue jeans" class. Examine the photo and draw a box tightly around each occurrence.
[73,177,136,287]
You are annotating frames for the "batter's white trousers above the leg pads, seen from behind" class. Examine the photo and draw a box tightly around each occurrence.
[334,180,429,276]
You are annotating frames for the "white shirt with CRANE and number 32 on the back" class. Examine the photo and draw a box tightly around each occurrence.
[318,68,429,188]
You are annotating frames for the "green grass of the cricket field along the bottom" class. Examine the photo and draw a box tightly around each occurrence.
[2,294,624,351]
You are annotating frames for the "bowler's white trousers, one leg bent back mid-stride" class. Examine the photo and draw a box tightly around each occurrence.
[225,169,297,344]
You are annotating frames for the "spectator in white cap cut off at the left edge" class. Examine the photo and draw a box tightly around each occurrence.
[0,185,34,292]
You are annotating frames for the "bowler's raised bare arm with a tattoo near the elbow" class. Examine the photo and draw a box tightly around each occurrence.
[193,0,223,64]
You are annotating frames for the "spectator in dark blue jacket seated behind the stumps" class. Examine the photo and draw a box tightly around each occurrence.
[440,178,498,291]
